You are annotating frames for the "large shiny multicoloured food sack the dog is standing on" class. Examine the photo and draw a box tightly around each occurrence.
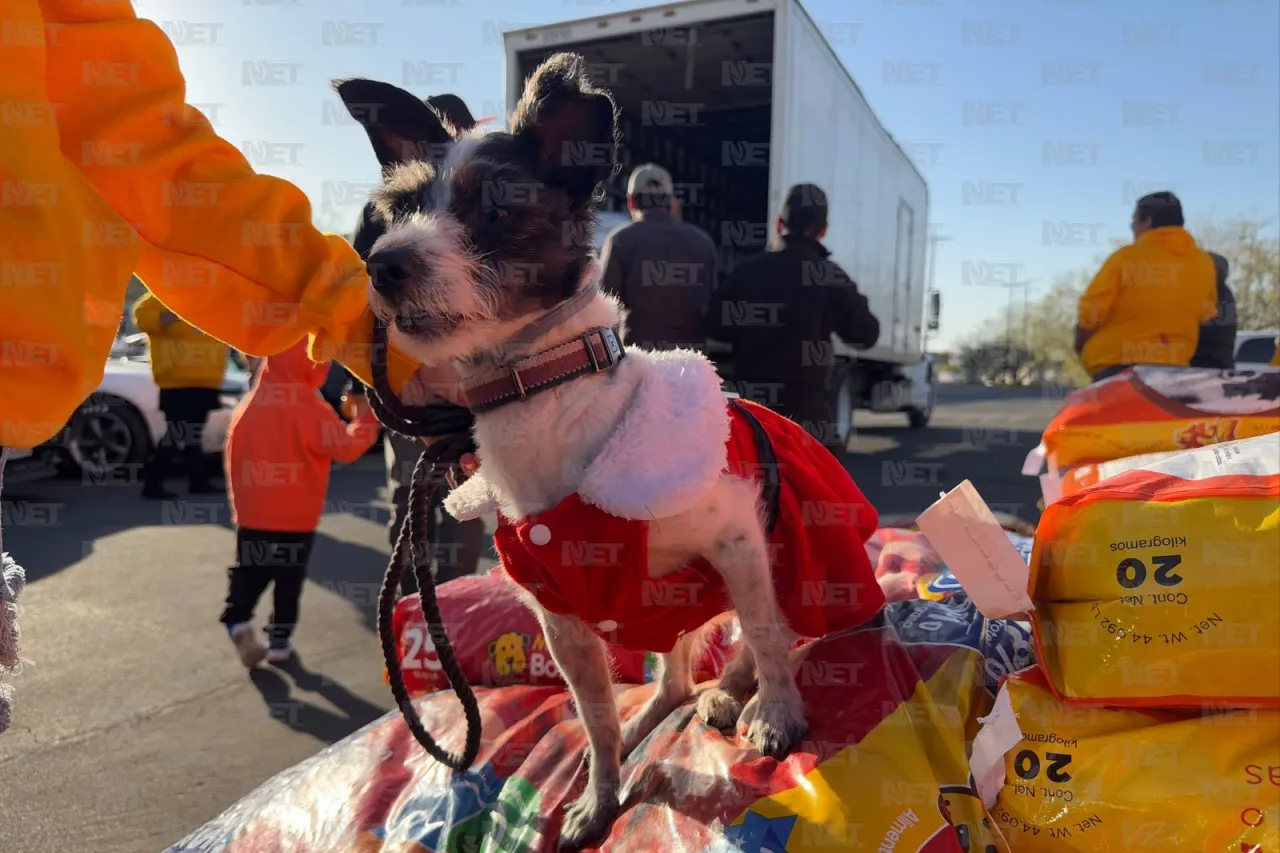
[169,602,1007,853]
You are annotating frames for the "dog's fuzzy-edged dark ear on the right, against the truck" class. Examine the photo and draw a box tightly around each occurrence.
[511,54,618,204]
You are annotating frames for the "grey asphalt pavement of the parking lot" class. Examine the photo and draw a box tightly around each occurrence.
[0,387,1061,853]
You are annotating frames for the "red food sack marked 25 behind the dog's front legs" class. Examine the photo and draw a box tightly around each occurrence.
[392,573,741,695]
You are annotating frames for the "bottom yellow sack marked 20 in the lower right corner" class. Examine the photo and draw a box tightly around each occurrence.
[973,669,1280,853]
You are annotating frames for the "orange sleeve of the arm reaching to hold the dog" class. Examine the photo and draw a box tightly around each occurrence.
[42,0,416,389]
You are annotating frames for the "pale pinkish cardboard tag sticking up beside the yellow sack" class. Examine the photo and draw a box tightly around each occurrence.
[916,480,1032,619]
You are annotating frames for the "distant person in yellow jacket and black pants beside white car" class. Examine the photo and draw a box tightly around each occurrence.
[133,293,230,500]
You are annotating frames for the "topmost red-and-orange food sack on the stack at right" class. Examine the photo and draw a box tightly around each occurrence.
[1024,366,1280,473]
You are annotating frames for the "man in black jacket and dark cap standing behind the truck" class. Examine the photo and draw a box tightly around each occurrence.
[707,183,879,451]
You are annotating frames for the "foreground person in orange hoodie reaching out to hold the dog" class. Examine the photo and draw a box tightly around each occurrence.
[0,0,474,730]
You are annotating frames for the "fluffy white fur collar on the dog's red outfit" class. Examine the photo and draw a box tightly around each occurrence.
[444,347,730,520]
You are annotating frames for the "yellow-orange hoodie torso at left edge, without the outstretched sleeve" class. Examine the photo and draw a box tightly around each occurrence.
[0,0,140,448]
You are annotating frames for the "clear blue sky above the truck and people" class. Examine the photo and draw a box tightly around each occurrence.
[134,0,1280,347]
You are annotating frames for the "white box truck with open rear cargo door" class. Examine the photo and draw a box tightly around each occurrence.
[504,0,940,435]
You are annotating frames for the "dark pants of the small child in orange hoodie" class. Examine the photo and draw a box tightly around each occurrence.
[220,528,316,646]
